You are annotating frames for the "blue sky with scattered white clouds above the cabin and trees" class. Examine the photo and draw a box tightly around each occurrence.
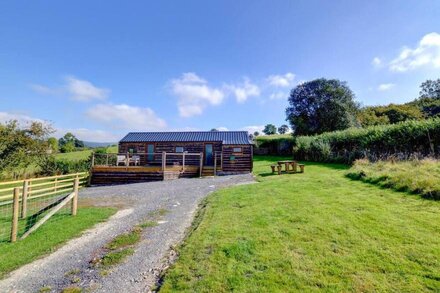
[0,0,440,142]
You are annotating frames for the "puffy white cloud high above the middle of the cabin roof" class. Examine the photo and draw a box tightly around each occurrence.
[171,72,225,117]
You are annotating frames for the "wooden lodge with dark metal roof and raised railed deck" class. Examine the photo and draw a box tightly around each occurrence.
[91,131,253,184]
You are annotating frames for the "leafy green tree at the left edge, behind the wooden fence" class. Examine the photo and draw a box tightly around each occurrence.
[0,120,52,177]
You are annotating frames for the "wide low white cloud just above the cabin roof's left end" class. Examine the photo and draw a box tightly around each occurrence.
[86,104,166,131]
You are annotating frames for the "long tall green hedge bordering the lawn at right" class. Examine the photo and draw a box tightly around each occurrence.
[293,118,440,163]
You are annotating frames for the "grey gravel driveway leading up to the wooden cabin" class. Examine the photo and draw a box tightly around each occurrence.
[0,174,253,292]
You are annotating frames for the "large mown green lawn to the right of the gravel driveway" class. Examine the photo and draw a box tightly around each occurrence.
[161,157,440,292]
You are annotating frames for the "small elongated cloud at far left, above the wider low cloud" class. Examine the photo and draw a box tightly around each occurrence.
[30,76,110,102]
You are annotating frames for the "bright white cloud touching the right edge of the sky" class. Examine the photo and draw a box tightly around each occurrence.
[389,32,440,72]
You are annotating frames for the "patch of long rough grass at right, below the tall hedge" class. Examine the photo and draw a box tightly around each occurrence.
[347,159,440,200]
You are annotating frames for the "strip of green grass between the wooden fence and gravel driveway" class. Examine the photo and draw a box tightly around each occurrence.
[0,207,116,277]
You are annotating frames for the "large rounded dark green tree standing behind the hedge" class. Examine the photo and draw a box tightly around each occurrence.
[286,78,359,135]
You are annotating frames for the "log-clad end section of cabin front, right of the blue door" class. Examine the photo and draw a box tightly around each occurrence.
[222,145,253,174]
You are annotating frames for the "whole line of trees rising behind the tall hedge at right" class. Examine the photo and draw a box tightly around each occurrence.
[262,78,440,136]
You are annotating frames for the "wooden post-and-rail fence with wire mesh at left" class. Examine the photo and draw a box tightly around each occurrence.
[0,172,88,243]
